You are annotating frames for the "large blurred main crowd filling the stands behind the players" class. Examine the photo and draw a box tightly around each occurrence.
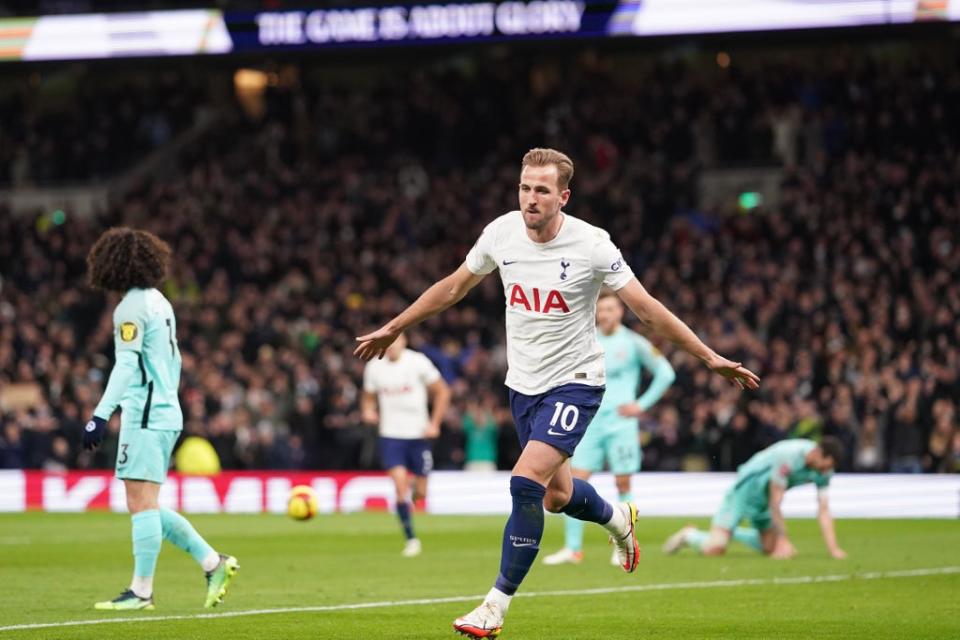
[0,45,960,472]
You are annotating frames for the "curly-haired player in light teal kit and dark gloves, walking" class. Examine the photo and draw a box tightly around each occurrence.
[83,228,239,610]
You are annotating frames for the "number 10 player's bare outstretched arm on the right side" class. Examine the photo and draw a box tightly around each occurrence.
[617,278,760,389]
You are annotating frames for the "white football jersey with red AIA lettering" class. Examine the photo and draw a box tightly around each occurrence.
[466,211,633,395]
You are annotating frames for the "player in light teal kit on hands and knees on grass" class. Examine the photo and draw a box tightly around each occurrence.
[663,436,847,560]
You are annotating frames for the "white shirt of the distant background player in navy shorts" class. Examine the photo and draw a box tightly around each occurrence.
[363,349,440,440]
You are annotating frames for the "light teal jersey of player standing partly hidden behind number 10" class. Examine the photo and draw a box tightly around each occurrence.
[597,326,676,417]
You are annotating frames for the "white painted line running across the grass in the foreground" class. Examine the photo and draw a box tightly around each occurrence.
[0,567,960,631]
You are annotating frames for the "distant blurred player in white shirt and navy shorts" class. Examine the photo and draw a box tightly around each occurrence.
[360,335,450,558]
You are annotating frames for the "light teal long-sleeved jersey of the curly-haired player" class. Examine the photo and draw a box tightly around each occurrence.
[94,289,183,431]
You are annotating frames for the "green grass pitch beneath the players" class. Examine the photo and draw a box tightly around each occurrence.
[0,513,960,640]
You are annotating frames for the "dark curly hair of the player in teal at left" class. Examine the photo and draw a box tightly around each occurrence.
[87,227,172,292]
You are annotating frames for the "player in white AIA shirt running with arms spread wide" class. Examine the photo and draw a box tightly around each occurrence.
[354,149,759,638]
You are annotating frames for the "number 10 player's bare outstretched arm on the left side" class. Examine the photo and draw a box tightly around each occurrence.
[353,263,484,360]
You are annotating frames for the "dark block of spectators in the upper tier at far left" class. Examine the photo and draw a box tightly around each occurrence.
[0,68,203,188]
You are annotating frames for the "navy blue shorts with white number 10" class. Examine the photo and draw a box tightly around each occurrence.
[510,384,604,456]
